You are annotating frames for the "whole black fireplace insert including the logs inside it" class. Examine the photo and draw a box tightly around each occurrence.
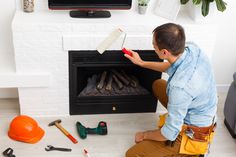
[69,50,162,115]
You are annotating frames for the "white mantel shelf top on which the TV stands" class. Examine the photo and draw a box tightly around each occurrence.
[12,10,216,34]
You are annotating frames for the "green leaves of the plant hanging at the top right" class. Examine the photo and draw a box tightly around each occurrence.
[180,0,227,17]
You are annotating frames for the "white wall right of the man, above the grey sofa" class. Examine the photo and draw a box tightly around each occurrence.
[212,0,236,86]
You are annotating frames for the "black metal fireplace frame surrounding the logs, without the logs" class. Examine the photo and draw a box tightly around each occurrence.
[69,50,163,115]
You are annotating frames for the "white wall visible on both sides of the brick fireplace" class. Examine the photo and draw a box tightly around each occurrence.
[0,0,236,98]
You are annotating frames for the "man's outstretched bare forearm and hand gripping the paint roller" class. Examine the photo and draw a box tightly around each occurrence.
[125,50,170,72]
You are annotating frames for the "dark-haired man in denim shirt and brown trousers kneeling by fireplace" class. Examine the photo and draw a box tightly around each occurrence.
[125,23,217,157]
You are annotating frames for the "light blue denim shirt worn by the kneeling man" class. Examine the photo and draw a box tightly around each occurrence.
[161,43,217,141]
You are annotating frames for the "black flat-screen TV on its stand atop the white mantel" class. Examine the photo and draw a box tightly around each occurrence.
[48,0,132,18]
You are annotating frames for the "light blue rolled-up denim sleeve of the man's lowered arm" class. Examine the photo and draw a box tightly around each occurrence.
[161,87,192,141]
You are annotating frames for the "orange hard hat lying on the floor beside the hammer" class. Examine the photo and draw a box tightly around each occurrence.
[8,115,44,143]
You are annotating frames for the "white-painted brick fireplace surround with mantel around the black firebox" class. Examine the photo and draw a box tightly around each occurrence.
[12,0,217,116]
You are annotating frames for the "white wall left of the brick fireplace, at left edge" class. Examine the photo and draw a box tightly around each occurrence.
[0,0,18,98]
